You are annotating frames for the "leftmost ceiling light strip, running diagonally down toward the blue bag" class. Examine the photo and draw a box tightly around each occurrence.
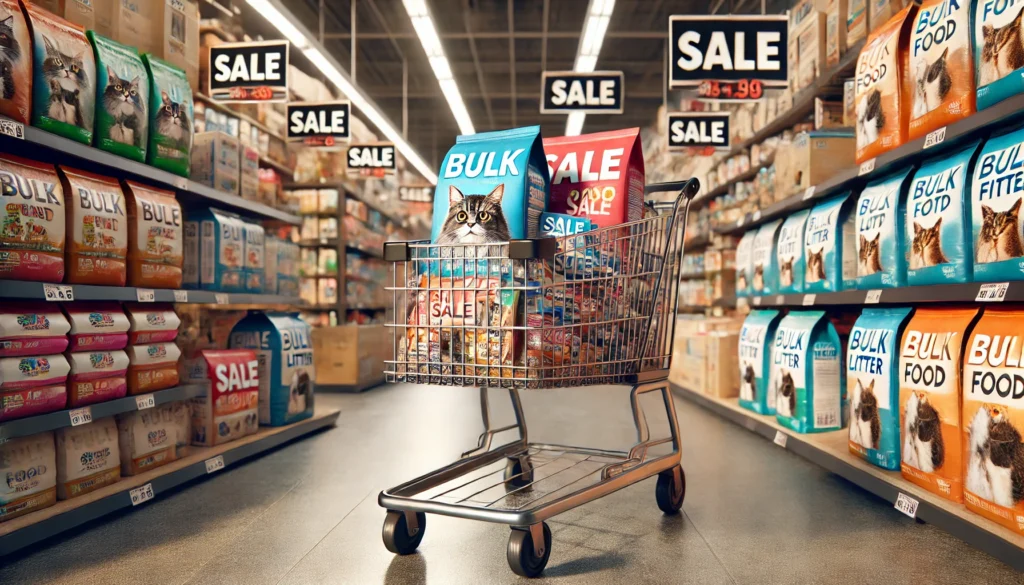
[246,0,437,184]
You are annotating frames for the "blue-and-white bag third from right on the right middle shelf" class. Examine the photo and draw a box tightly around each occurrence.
[856,168,910,289]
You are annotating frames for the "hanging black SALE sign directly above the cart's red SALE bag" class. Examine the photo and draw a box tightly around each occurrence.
[541,71,625,114]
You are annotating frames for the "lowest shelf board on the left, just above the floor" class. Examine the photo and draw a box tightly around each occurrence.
[0,409,339,556]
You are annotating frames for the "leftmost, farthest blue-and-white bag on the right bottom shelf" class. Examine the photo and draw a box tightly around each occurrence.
[739,309,781,415]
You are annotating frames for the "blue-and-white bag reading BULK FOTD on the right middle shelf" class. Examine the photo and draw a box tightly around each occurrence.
[903,142,980,286]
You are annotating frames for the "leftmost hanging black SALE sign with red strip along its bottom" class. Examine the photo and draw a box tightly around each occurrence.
[210,41,289,102]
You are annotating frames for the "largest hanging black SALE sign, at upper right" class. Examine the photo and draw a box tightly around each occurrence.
[669,14,788,88]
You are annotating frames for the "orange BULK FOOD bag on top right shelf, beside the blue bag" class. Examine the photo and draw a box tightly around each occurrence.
[906,0,975,140]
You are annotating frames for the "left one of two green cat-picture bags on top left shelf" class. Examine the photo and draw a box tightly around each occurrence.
[86,31,150,162]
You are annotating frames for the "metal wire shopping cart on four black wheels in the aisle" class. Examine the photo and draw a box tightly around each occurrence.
[378,179,699,577]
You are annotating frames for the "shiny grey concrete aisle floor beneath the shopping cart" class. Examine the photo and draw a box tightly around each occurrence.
[0,385,1024,585]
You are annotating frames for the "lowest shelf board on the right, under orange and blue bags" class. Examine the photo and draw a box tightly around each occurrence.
[673,384,1024,571]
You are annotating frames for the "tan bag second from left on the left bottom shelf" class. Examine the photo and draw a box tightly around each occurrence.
[55,417,121,500]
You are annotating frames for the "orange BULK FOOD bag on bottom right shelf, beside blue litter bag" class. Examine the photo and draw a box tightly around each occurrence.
[897,307,978,502]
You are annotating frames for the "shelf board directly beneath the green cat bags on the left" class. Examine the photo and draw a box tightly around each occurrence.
[0,126,302,225]
